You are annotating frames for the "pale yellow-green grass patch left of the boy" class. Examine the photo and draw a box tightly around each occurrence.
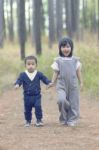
[0,43,21,93]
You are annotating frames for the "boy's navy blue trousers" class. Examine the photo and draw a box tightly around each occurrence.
[24,95,42,123]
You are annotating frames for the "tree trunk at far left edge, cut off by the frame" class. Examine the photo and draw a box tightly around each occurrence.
[0,0,4,48]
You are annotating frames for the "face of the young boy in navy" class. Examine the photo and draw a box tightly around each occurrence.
[25,59,37,73]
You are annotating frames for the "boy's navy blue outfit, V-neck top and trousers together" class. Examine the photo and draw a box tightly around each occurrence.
[15,71,51,123]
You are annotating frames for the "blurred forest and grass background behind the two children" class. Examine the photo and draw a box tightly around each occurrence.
[0,0,99,98]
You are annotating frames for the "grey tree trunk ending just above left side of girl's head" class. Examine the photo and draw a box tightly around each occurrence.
[56,0,63,40]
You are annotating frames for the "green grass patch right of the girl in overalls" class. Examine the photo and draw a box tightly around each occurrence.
[77,40,99,95]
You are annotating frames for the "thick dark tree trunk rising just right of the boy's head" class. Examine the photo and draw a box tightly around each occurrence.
[33,0,42,55]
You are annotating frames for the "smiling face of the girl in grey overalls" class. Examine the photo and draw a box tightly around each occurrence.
[61,43,71,57]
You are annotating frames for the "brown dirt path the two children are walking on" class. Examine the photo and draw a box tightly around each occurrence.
[0,87,99,150]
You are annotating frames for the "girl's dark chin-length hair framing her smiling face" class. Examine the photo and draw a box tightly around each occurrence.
[59,37,74,57]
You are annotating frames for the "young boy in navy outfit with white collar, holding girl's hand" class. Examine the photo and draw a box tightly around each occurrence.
[15,56,51,127]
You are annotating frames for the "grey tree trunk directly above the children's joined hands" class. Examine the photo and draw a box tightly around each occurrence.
[48,0,55,48]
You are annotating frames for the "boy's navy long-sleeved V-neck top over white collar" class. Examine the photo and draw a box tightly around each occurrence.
[15,71,51,96]
